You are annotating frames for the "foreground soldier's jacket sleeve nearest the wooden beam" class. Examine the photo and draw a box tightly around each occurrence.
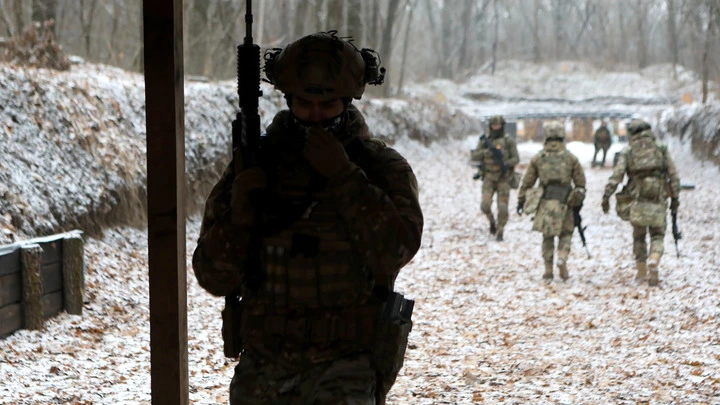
[192,162,250,296]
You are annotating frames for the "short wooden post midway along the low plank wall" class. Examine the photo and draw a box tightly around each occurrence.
[20,244,45,329]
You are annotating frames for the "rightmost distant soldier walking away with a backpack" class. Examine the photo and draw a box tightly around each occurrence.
[602,119,680,286]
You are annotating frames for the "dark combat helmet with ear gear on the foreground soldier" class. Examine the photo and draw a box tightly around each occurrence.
[264,31,385,100]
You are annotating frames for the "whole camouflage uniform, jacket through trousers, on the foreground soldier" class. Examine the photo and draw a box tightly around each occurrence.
[193,34,423,405]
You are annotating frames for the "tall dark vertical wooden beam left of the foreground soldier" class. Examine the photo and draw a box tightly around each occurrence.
[143,0,189,405]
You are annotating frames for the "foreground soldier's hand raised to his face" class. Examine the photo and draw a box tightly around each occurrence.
[303,125,352,178]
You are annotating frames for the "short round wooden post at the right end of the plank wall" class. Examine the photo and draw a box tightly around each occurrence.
[62,234,84,315]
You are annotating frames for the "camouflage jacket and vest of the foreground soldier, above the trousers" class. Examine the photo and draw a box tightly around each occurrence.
[193,105,423,403]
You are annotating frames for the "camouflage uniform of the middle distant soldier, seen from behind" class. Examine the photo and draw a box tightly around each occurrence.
[518,141,586,263]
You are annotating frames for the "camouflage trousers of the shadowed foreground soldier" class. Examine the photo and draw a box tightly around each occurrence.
[230,351,376,405]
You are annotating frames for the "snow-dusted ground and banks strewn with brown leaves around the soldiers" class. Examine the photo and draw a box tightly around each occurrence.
[0,61,720,405]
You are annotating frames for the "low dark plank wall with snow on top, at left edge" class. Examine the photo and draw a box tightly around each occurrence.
[0,231,84,337]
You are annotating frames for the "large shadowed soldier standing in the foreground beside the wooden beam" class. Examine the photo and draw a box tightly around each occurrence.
[193,31,423,405]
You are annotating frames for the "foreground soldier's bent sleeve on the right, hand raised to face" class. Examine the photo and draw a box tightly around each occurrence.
[328,147,423,285]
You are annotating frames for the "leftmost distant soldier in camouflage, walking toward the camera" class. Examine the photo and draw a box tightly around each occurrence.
[471,115,519,240]
